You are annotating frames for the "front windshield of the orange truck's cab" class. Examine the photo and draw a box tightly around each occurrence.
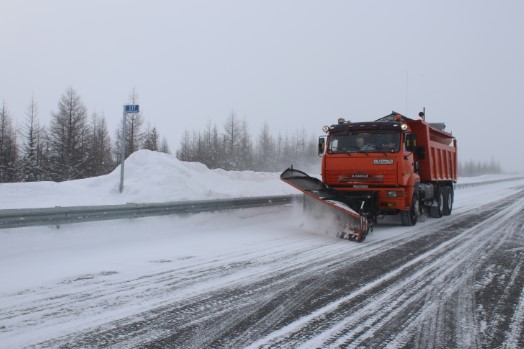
[327,131,400,154]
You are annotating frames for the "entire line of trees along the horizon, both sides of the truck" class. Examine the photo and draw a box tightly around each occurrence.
[4,87,503,183]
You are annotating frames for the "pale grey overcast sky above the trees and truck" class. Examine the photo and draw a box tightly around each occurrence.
[0,0,524,172]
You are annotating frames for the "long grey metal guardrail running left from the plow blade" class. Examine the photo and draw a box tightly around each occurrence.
[0,194,302,229]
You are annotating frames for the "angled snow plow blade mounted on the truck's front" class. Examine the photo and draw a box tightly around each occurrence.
[280,168,371,242]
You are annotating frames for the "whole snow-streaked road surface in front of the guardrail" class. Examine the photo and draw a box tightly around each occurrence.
[0,180,524,348]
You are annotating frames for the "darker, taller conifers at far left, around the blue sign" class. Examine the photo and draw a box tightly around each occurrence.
[0,87,170,183]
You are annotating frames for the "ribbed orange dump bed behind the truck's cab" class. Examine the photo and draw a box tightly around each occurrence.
[408,120,457,182]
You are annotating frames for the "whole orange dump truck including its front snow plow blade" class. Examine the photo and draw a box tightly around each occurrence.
[281,112,457,241]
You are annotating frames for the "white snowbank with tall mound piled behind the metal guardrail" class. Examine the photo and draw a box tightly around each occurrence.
[0,150,299,209]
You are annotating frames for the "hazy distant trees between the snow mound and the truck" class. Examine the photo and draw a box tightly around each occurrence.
[176,112,320,173]
